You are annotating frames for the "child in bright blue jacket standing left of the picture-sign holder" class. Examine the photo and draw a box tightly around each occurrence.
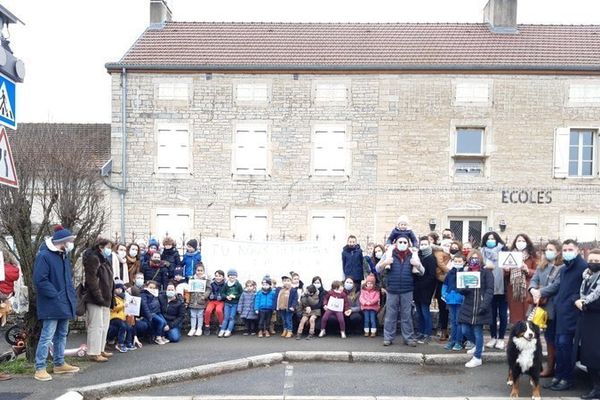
[442,253,467,351]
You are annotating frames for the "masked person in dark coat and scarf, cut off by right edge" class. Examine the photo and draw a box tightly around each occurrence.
[575,249,600,399]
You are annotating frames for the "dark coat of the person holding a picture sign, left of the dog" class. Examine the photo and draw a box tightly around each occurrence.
[458,265,494,325]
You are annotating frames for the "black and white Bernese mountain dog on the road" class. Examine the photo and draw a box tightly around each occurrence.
[506,321,542,400]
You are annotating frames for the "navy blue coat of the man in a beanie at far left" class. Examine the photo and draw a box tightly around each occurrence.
[33,239,77,320]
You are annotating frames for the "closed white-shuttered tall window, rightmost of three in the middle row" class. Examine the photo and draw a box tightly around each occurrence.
[312,125,349,175]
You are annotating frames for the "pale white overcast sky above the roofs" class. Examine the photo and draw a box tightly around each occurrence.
[0,0,600,122]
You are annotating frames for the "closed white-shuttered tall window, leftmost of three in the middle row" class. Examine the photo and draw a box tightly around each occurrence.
[156,123,191,173]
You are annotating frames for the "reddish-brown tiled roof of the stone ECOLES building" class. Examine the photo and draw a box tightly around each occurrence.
[106,22,600,72]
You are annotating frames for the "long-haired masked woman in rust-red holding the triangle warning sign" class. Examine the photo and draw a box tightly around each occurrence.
[504,233,537,324]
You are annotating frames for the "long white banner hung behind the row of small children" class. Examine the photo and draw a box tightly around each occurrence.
[202,238,344,290]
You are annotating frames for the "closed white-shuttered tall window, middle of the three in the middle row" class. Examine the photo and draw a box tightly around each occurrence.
[233,124,269,175]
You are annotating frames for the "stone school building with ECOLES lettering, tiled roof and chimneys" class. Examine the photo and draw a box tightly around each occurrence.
[106,0,600,245]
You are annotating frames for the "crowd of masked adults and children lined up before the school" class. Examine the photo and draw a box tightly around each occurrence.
[0,216,600,398]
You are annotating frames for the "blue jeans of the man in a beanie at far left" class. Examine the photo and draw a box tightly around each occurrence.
[35,319,69,370]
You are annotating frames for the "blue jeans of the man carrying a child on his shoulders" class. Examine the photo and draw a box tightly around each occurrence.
[383,292,414,342]
